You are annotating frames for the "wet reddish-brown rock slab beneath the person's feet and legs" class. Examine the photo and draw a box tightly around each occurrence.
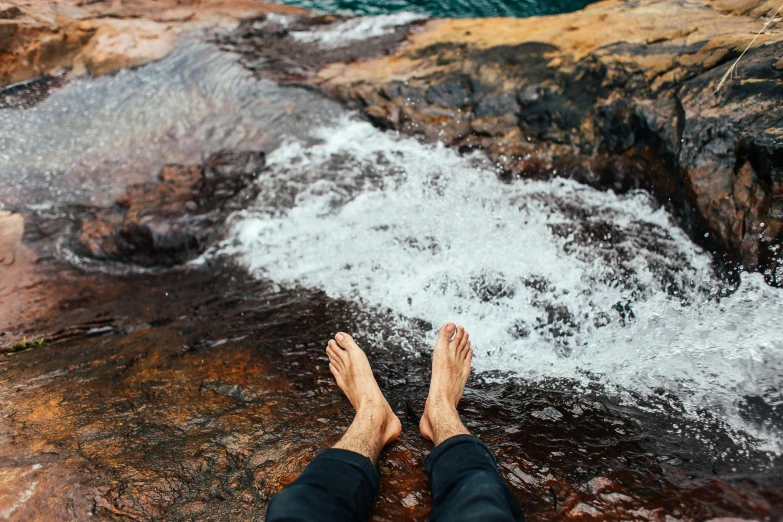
[0,240,783,521]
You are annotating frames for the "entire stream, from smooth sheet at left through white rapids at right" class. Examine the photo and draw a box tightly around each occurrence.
[0,35,783,516]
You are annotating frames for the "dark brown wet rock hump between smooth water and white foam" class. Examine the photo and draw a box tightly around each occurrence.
[78,151,264,266]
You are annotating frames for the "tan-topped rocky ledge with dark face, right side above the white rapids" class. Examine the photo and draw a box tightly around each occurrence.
[226,0,783,285]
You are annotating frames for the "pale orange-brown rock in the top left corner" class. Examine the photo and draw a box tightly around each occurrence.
[0,0,304,87]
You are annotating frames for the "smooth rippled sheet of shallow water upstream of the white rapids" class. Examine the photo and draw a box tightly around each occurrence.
[0,42,344,208]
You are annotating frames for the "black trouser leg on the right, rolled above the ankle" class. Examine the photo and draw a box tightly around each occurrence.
[424,435,525,522]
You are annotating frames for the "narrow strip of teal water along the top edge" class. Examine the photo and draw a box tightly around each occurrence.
[274,0,593,18]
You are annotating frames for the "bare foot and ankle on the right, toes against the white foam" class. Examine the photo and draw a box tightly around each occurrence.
[419,323,473,446]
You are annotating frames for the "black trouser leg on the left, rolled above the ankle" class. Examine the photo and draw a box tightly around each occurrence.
[266,448,380,522]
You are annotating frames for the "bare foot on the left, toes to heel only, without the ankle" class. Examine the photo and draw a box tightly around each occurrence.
[326,332,402,445]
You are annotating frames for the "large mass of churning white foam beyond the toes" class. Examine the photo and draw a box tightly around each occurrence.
[223,118,783,450]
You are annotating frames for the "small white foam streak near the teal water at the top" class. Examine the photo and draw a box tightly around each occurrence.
[290,12,426,48]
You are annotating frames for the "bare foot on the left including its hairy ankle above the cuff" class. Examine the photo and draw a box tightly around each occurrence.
[326,332,402,461]
